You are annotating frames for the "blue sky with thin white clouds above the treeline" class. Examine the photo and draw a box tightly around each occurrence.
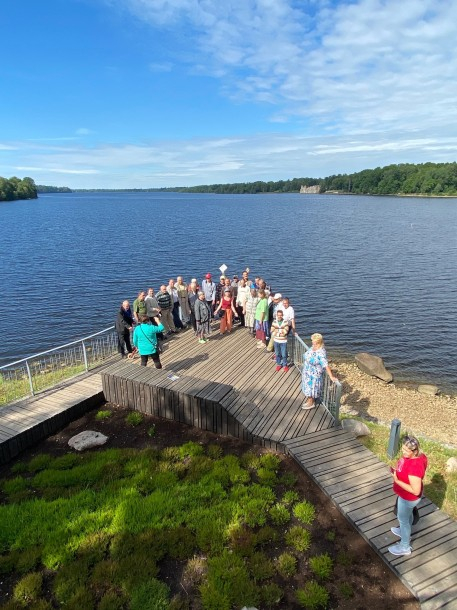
[0,0,457,188]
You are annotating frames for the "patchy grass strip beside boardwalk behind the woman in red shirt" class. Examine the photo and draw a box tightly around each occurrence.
[342,418,457,519]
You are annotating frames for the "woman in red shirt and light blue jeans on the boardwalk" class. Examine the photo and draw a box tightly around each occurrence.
[389,436,427,555]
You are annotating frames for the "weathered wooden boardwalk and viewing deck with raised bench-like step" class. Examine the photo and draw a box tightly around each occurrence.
[0,328,457,610]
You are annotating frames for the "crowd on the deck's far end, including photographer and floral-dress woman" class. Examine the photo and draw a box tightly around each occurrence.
[116,269,336,409]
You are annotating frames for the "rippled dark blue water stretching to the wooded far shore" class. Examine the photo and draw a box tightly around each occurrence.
[0,193,457,392]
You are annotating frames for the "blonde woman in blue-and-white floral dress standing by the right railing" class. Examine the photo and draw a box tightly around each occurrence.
[301,333,337,409]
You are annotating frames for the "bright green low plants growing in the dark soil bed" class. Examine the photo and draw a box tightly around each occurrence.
[0,442,350,610]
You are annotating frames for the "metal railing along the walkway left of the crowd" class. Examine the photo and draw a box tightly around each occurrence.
[0,326,117,405]
